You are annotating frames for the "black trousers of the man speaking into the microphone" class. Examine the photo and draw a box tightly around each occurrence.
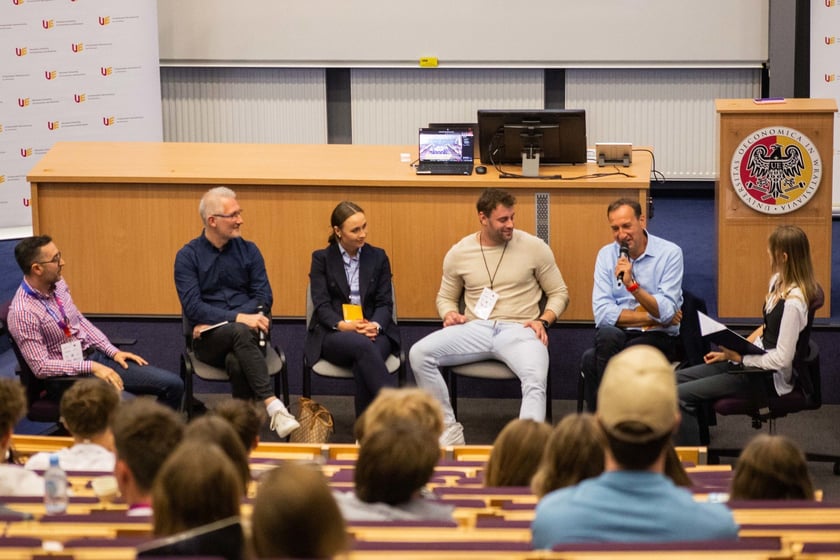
[580,327,677,412]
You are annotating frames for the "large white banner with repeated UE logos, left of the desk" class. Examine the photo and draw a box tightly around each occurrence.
[0,0,163,239]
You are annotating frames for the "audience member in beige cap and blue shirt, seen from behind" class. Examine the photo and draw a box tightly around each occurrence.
[531,345,738,548]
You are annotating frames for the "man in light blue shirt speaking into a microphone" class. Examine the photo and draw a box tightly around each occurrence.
[581,198,683,412]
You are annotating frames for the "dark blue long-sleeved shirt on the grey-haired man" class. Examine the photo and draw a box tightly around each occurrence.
[175,233,273,327]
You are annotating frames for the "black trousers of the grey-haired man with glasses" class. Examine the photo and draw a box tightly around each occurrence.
[193,323,275,400]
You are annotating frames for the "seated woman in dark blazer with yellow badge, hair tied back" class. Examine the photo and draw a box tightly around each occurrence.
[304,201,400,416]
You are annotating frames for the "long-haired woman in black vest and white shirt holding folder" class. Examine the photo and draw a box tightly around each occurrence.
[677,226,822,445]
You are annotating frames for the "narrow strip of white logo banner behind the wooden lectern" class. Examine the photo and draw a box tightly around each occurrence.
[811,0,840,216]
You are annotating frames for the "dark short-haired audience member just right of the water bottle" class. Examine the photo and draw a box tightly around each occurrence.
[111,399,184,516]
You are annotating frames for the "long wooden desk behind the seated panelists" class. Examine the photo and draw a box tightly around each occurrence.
[27,142,651,320]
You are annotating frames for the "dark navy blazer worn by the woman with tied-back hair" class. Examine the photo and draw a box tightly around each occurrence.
[303,243,401,365]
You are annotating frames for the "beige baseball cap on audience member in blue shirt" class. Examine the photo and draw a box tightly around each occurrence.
[598,345,679,443]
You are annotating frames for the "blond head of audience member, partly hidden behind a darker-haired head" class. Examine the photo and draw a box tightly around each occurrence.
[353,387,443,441]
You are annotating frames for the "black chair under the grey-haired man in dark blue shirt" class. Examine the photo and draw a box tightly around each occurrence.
[181,313,289,419]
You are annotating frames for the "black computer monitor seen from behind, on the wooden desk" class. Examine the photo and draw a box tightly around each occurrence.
[478,109,586,177]
